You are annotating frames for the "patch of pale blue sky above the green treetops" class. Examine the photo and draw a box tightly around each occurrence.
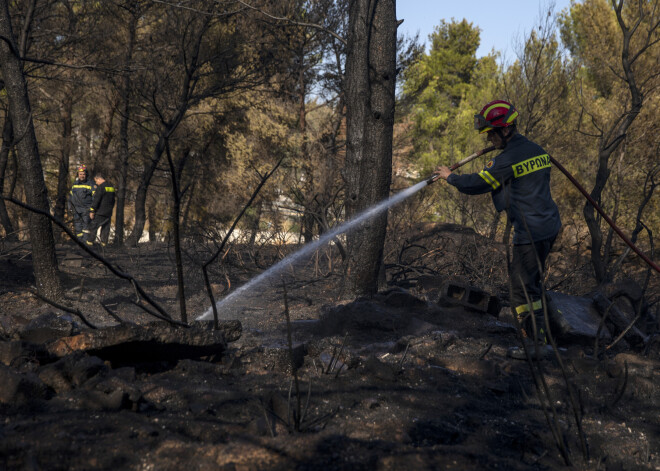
[396,0,571,60]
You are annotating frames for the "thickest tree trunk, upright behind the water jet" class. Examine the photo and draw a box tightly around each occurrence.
[344,0,397,295]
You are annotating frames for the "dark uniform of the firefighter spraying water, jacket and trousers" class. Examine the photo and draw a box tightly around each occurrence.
[447,134,561,337]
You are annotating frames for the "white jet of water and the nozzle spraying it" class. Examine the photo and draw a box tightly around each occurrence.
[197,147,495,320]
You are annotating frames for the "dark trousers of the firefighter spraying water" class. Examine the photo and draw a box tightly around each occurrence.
[509,236,556,316]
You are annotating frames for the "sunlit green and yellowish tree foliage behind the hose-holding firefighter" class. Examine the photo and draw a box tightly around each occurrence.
[401,0,660,278]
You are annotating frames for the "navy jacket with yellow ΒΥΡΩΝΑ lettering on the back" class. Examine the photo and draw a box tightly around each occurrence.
[447,134,561,245]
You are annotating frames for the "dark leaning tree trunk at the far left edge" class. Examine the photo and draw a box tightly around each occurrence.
[0,2,62,300]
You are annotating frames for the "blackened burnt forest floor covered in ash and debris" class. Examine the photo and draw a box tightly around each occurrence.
[0,233,660,470]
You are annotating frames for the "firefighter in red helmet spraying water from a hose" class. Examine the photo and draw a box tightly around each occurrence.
[435,100,561,357]
